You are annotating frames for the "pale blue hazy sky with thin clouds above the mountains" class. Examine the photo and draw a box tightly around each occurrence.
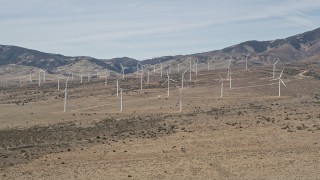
[0,0,320,60]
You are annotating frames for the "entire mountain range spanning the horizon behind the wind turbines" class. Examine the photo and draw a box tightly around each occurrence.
[0,28,320,74]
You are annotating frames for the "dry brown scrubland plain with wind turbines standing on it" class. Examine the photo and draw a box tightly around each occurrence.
[0,62,320,179]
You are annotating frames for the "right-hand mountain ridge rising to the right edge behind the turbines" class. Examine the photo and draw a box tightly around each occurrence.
[172,28,320,68]
